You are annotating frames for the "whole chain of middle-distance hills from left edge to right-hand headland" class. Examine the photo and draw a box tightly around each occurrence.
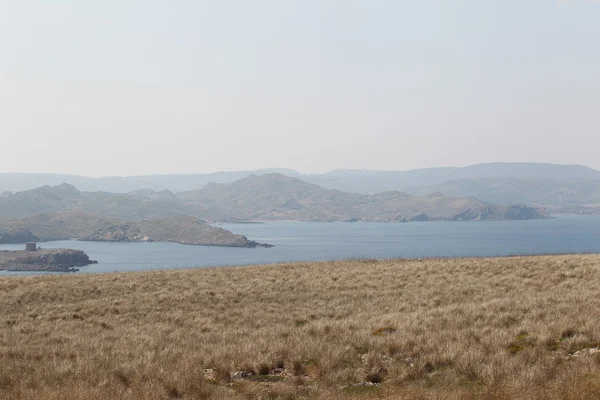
[0,173,544,221]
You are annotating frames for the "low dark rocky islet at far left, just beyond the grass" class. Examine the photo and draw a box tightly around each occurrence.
[0,249,98,272]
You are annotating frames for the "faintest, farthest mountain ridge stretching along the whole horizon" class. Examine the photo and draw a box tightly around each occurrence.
[0,163,600,194]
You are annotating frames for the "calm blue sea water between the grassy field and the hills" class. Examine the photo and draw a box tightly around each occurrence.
[0,215,600,275]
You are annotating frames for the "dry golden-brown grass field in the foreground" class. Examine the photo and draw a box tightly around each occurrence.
[0,255,600,400]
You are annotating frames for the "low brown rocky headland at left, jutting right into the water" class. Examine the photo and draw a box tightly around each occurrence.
[0,211,269,247]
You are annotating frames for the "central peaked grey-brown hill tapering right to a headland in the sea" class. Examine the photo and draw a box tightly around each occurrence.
[178,174,543,221]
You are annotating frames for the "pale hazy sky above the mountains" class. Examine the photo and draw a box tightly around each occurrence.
[0,0,600,176]
